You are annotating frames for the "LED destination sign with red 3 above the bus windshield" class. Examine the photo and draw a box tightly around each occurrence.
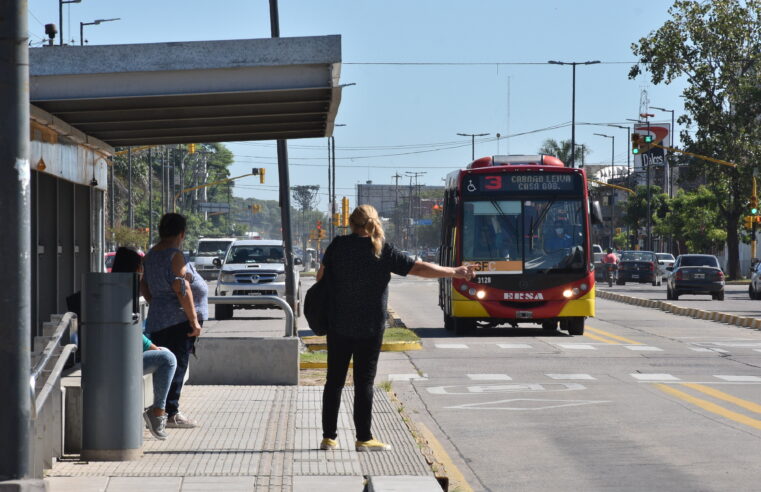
[463,173,581,194]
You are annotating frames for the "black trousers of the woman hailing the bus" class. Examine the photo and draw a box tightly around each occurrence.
[322,332,383,441]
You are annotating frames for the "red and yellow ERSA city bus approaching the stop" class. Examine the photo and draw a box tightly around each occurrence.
[439,155,597,335]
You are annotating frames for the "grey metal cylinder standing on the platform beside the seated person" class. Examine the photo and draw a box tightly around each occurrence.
[82,273,143,461]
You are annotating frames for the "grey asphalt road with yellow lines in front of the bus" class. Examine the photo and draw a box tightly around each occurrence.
[388,278,761,491]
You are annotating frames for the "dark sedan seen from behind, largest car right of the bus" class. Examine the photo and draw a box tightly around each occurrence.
[666,255,724,301]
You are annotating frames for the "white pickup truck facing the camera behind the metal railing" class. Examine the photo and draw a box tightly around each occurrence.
[215,239,302,320]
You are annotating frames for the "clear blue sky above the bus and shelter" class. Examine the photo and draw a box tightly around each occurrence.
[29,0,683,210]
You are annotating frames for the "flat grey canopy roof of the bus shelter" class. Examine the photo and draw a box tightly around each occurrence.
[29,35,341,147]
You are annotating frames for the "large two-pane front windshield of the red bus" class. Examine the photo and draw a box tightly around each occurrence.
[462,198,586,274]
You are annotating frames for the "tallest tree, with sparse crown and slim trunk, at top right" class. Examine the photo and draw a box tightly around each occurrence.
[629,0,761,278]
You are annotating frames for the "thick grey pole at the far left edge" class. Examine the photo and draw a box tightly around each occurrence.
[0,0,31,476]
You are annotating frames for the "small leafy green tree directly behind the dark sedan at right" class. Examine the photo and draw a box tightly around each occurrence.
[662,186,727,254]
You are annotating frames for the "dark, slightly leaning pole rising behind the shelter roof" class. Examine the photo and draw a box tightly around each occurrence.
[270,0,296,320]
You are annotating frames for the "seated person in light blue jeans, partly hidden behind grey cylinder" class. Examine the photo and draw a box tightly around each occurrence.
[111,247,177,440]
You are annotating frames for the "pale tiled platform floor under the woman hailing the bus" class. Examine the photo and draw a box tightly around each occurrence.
[45,386,441,492]
